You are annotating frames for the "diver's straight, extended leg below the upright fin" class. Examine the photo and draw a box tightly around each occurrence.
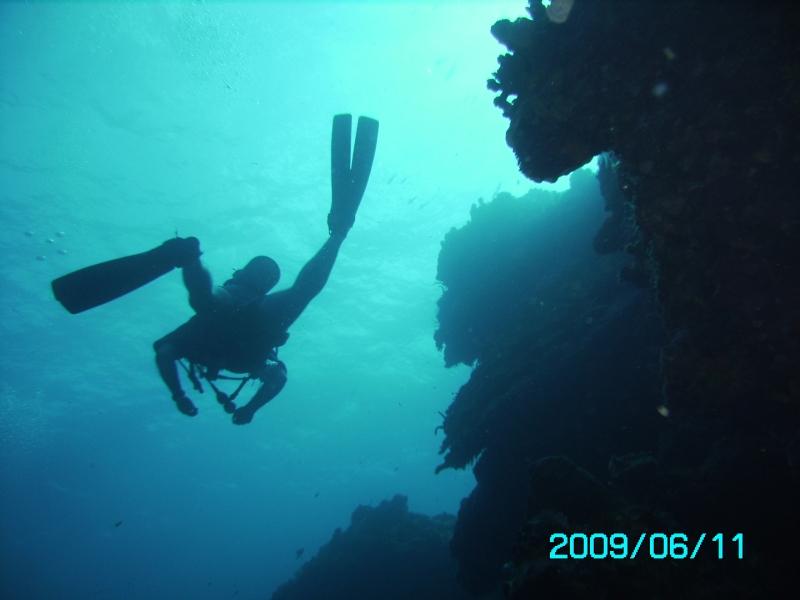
[264,235,344,329]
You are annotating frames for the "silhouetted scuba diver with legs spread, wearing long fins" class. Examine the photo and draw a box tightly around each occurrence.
[52,114,378,425]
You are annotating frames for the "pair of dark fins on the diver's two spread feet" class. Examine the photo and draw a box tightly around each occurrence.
[51,114,378,314]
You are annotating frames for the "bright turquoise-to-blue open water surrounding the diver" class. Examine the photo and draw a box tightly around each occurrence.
[0,0,556,599]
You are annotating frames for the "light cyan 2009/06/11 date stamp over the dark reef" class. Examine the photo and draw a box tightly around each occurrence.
[550,532,744,560]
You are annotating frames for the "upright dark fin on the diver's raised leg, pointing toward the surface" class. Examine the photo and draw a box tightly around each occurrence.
[328,114,378,234]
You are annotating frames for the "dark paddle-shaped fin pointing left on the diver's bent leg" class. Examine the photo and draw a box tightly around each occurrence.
[51,238,200,314]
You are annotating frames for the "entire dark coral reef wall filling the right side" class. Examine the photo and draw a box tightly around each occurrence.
[436,0,800,598]
